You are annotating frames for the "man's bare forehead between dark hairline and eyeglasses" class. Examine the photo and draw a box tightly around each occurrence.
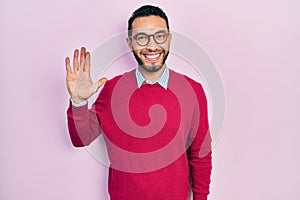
[132,15,167,31]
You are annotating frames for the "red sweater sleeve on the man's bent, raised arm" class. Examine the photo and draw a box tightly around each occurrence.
[67,83,108,147]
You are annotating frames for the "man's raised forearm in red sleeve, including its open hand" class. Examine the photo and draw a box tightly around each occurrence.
[65,47,107,147]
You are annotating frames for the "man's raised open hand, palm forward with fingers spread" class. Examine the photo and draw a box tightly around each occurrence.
[65,47,107,103]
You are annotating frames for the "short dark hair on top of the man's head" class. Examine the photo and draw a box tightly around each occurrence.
[128,5,169,36]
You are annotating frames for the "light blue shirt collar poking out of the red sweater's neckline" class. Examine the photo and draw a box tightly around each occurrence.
[135,67,169,89]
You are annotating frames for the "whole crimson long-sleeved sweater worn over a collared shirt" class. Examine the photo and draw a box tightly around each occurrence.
[67,70,212,200]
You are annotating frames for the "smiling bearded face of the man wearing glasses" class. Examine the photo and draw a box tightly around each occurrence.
[127,15,172,72]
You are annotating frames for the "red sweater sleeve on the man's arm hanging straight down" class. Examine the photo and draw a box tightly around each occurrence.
[187,82,212,200]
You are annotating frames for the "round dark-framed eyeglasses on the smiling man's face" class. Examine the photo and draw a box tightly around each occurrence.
[130,30,170,46]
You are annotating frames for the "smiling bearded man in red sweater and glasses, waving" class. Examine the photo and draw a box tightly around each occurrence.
[66,5,211,200]
